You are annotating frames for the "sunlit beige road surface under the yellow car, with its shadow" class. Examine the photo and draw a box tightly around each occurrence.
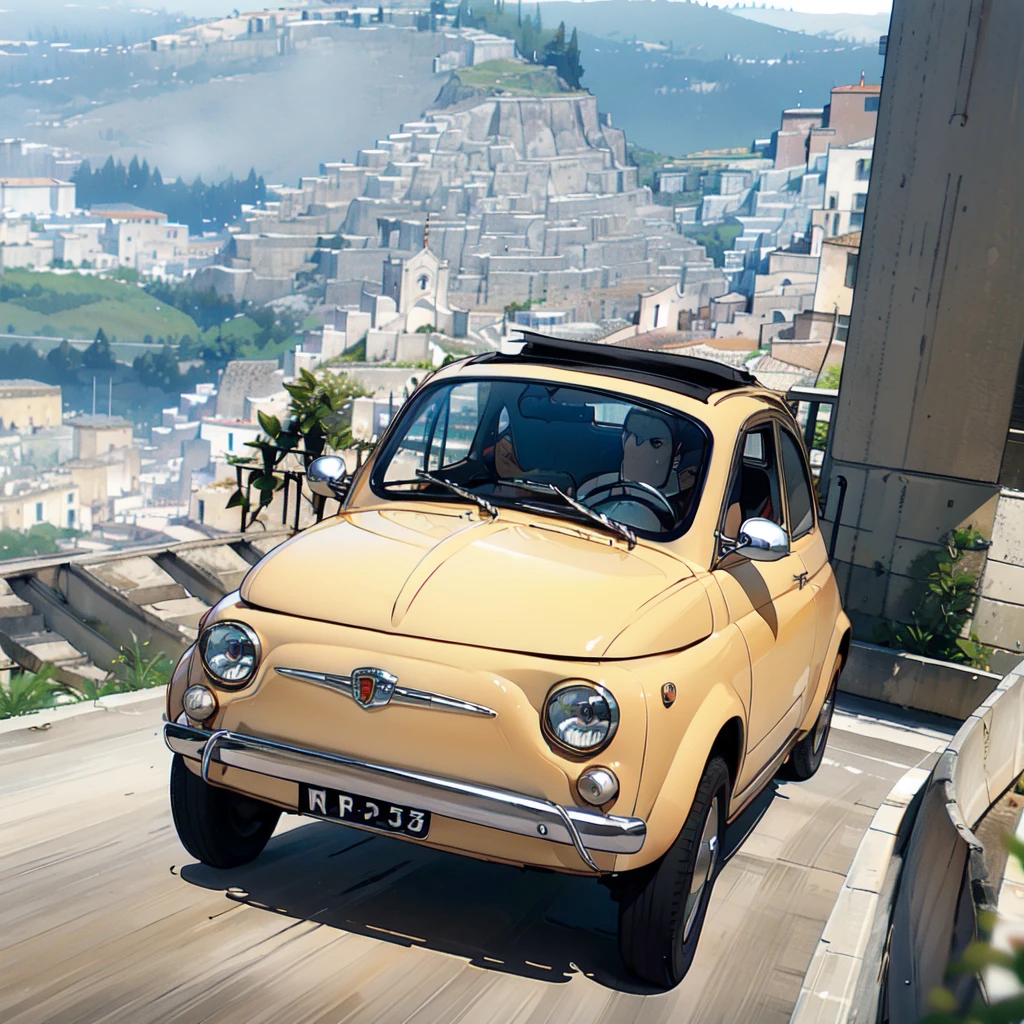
[0,697,949,1024]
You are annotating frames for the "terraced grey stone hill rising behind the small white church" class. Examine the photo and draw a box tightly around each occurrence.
[218,79,729,326]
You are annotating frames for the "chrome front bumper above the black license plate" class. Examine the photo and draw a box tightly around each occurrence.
[164,722,647,871]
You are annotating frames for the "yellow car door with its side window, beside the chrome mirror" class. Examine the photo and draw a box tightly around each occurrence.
[713,417,816,791]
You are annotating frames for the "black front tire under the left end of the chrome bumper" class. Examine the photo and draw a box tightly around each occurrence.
[171,754,281,867]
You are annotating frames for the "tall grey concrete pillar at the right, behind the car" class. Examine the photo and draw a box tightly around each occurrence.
[824,0,1024,636]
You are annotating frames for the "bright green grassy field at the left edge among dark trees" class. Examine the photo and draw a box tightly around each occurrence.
[0,270,200,341]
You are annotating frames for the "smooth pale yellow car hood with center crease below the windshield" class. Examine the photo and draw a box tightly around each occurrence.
[241,509,713,658]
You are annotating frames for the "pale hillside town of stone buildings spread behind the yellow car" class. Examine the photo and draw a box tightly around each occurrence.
[0,11,880,561]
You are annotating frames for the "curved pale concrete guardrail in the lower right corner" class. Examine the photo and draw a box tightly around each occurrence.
[793,662,1024,1024]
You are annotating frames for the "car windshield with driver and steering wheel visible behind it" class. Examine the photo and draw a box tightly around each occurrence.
[371,378,710,540]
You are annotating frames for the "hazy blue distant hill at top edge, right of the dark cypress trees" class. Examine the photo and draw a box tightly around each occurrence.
[541,0,834,60]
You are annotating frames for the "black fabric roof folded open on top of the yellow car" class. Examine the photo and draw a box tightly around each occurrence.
[472,331,758,401]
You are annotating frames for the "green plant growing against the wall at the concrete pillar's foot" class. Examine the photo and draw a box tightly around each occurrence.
[879,526,991,670]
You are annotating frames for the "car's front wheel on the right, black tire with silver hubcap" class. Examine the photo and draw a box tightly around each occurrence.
[618,756,729,988]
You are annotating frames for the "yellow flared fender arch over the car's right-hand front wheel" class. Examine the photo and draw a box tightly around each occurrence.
[615,682,746,870]
